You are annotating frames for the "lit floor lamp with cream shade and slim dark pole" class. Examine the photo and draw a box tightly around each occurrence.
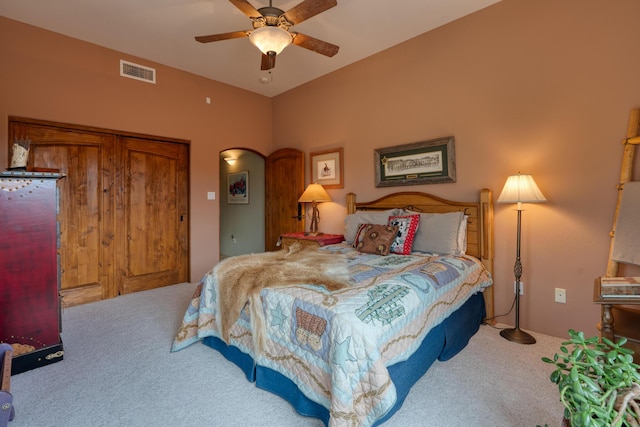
[498,173,547,344]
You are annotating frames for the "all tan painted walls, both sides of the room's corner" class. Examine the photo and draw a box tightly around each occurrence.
[0,0,640,342]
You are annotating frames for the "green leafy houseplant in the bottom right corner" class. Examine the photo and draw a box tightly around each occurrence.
[542,330,640,427]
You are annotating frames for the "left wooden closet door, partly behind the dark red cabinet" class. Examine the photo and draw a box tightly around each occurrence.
[9,122,116,307]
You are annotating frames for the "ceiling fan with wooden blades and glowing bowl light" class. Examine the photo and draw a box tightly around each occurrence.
[196,0,340,70]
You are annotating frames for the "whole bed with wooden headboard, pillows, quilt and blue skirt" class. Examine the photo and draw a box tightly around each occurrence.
[172,189,493,426]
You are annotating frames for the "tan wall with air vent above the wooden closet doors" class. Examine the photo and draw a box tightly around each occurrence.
[0,17,271,281]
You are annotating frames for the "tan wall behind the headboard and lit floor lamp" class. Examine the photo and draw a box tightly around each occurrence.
[273,0,640,342]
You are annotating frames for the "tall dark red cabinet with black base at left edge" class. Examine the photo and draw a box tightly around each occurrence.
[0,172,64,374]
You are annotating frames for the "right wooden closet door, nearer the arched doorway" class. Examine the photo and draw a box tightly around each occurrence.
[116,137,189,293]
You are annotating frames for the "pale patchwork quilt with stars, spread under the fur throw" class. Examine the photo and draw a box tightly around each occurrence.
[172,244,492,427]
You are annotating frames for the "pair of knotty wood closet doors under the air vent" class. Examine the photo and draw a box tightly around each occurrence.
[9,117,189,306]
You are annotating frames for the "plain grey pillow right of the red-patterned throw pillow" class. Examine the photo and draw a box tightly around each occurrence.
[413,212,466,255]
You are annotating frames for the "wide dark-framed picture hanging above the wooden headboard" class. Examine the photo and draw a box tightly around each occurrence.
[374,136,456,187]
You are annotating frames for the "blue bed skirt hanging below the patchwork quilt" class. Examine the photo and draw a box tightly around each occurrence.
[204,292,486,425]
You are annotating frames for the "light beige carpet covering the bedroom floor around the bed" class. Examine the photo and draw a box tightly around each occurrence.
[9,284,563,427]
